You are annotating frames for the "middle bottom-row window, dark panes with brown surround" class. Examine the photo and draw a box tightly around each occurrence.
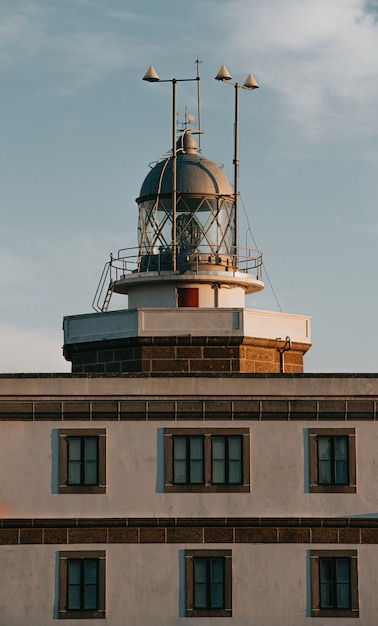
[185,550,232,617]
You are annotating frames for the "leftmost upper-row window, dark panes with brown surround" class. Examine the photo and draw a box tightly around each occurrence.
[59,428,106,493]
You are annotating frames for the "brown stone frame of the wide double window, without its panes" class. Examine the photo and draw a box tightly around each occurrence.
[164,428,251,493]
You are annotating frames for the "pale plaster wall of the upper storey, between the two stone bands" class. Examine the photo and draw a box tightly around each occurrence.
[0,421,378,518]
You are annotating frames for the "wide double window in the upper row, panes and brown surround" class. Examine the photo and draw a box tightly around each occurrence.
[165,428,250,492]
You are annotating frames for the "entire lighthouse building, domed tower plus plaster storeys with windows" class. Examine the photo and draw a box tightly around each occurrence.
[0,68,378,626]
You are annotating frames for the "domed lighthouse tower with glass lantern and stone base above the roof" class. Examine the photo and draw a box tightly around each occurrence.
[63,66,311,375]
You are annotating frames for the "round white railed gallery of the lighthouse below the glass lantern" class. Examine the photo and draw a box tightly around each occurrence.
[92,248,264,312]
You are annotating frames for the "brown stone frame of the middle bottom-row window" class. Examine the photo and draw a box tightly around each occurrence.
[185,550,232,617]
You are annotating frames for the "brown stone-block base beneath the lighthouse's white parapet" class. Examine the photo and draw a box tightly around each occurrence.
[64,336,310,374]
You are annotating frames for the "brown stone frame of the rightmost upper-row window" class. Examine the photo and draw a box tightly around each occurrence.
[309,428,357,493]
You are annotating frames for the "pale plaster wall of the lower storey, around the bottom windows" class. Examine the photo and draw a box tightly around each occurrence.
[0,544,378,626]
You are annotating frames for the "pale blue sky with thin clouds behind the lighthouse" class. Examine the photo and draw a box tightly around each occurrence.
[0,0,378,373]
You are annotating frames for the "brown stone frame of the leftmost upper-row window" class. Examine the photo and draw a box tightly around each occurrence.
[59,428,106,494]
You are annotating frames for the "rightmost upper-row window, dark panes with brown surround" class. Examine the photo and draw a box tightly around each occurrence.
[310,428,356,493]
